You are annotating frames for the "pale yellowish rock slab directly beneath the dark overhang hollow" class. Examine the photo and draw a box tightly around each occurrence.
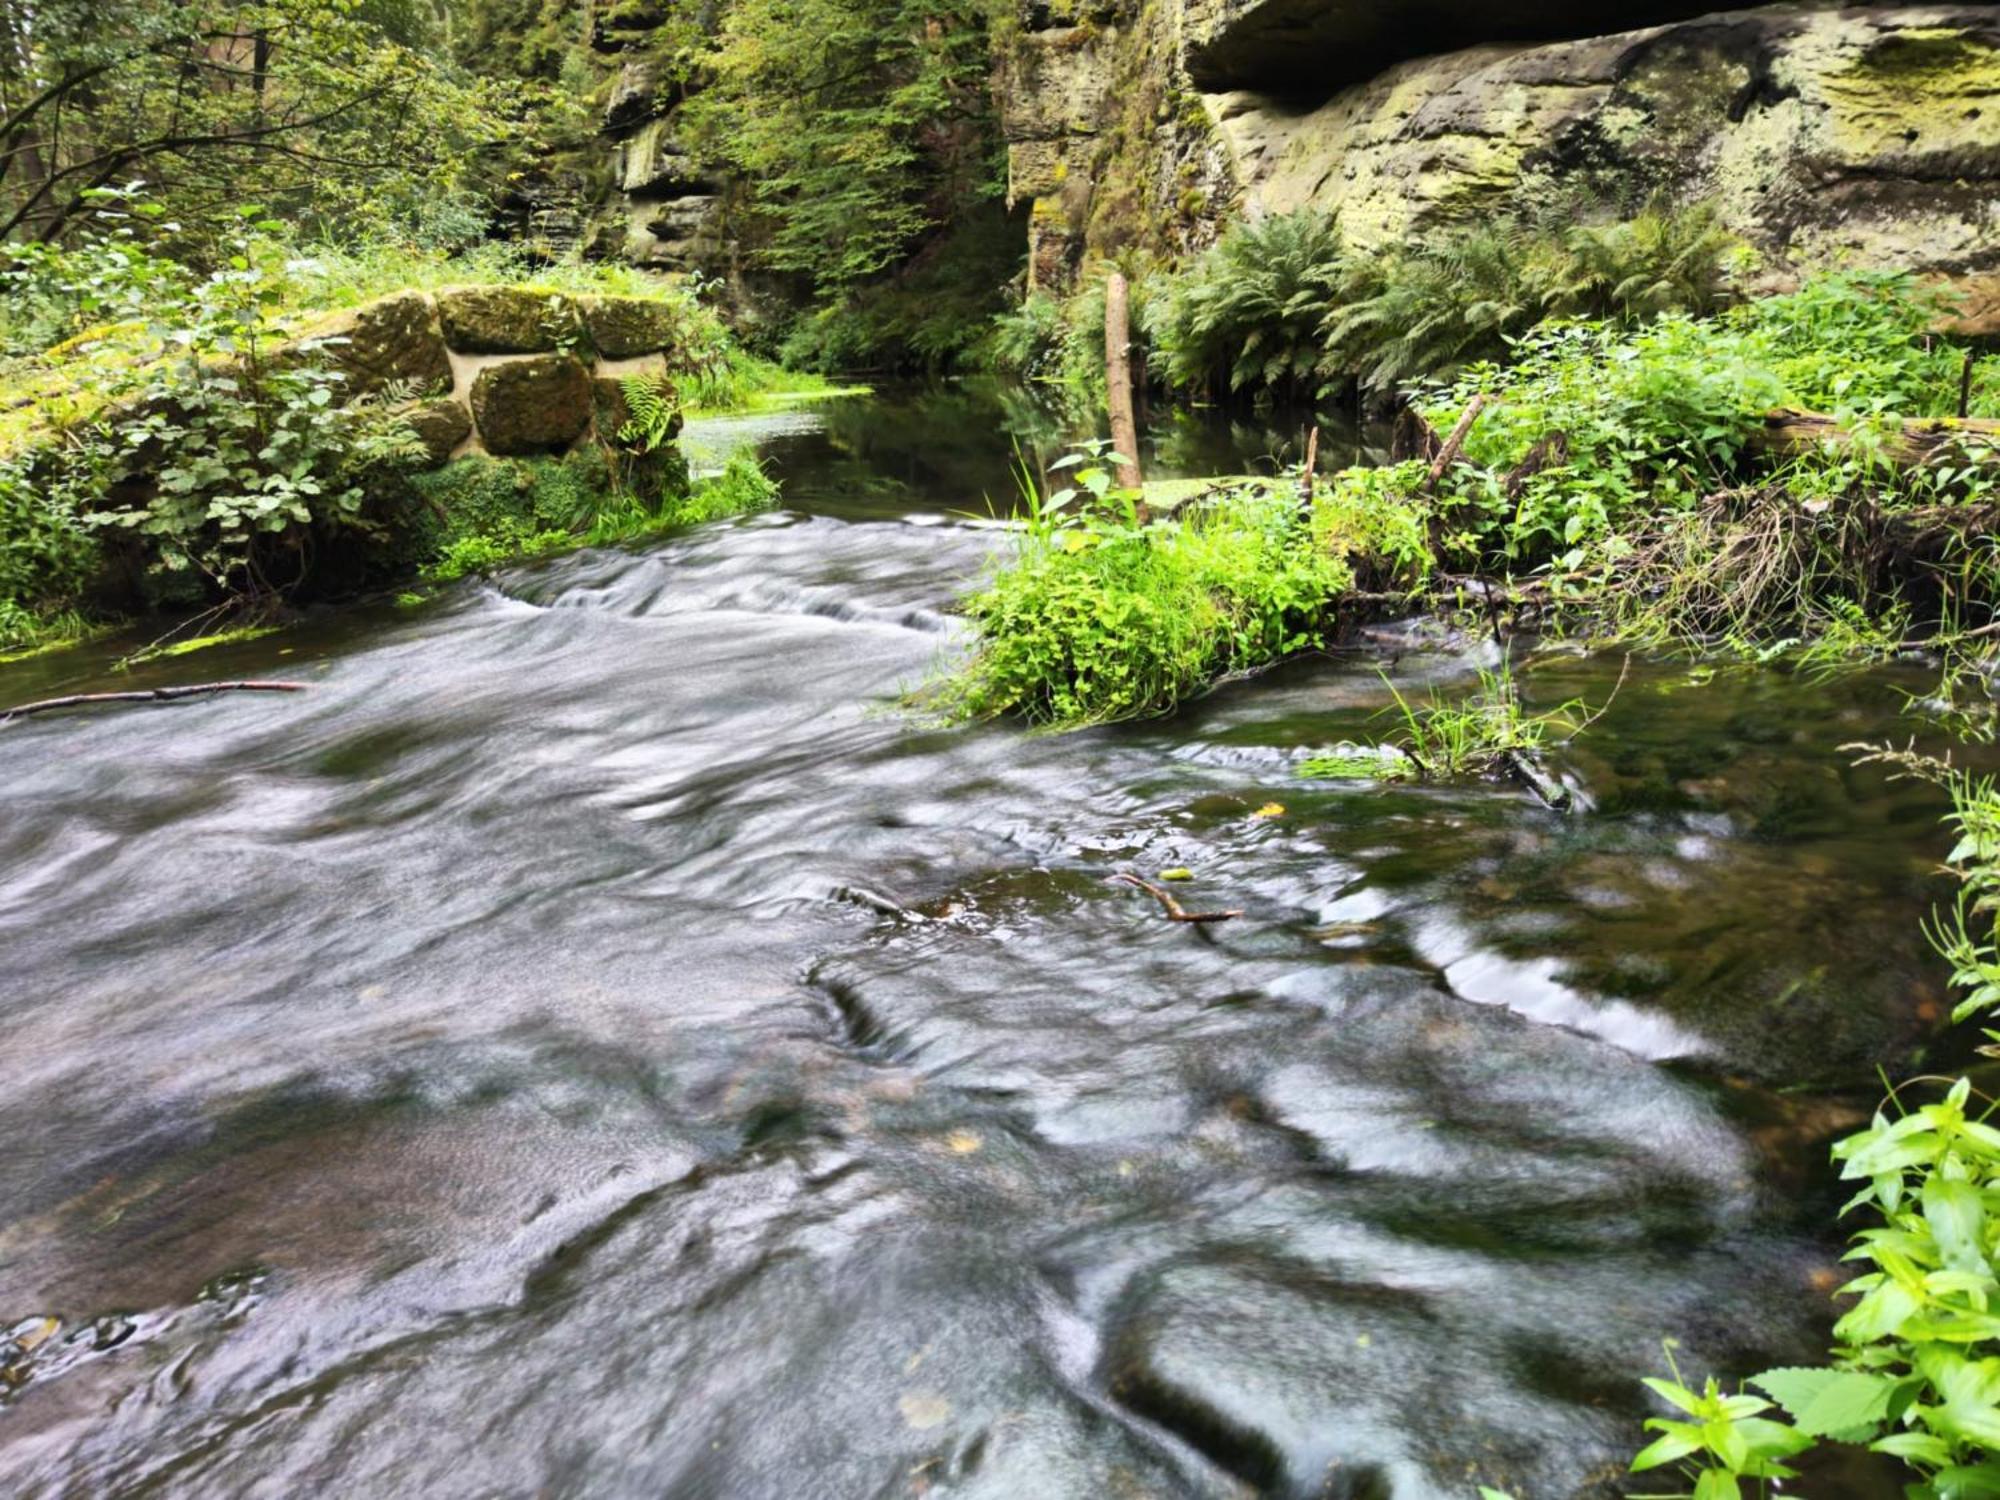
[1214,4,2000,274]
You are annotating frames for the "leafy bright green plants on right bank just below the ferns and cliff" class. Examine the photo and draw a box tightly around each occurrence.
[1418,274,1994,572]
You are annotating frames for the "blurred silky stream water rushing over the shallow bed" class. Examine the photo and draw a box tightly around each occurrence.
[0,384,1968,1500]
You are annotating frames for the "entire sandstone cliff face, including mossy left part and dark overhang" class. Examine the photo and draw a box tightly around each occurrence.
[1000,0,2000,288]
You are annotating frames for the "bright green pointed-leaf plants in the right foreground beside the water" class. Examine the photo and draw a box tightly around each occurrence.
[1634,768,2000,1500]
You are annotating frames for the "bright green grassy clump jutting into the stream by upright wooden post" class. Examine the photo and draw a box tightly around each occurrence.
[928,452,1354,728]
